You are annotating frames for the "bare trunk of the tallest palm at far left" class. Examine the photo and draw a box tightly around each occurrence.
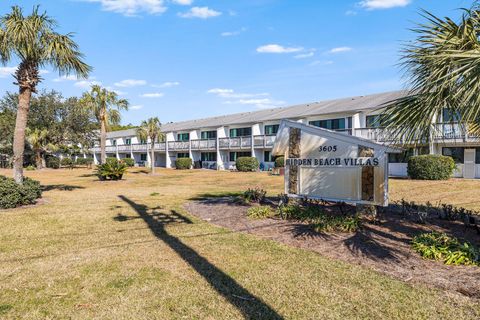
[13,88,32,184]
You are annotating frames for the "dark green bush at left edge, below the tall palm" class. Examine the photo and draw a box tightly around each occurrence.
[0,176,42,209]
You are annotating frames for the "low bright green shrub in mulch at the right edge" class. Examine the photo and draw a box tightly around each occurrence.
[412,232,480,265]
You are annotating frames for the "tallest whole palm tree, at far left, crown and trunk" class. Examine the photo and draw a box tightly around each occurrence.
[0,6,91,184]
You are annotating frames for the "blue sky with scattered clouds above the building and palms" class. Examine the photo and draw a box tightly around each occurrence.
[0,0,472,124]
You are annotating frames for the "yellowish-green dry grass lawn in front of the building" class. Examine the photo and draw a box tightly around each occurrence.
[0,169,480,319]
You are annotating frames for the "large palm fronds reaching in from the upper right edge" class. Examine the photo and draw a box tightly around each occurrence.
[381,2,480,143]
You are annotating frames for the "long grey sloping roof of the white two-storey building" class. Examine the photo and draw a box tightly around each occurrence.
[107,91,407,138]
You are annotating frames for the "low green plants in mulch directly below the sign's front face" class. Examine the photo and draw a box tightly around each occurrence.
[278,204,362,232]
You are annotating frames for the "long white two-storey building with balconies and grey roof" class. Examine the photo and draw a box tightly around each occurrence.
[92,91,480,178]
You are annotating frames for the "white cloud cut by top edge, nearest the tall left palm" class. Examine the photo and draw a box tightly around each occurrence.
[83,0,167,17]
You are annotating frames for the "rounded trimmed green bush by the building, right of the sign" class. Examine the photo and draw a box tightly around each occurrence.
[407,154,455,180]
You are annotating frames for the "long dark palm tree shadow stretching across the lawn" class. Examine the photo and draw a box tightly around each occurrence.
[115,196,283,319]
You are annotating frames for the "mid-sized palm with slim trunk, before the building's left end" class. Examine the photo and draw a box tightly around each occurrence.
[80,85,128,164]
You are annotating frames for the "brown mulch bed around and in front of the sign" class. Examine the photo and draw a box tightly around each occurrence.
[185,197,480,299]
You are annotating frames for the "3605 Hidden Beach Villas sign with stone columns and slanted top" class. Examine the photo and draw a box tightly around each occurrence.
[273,120,400,206]
